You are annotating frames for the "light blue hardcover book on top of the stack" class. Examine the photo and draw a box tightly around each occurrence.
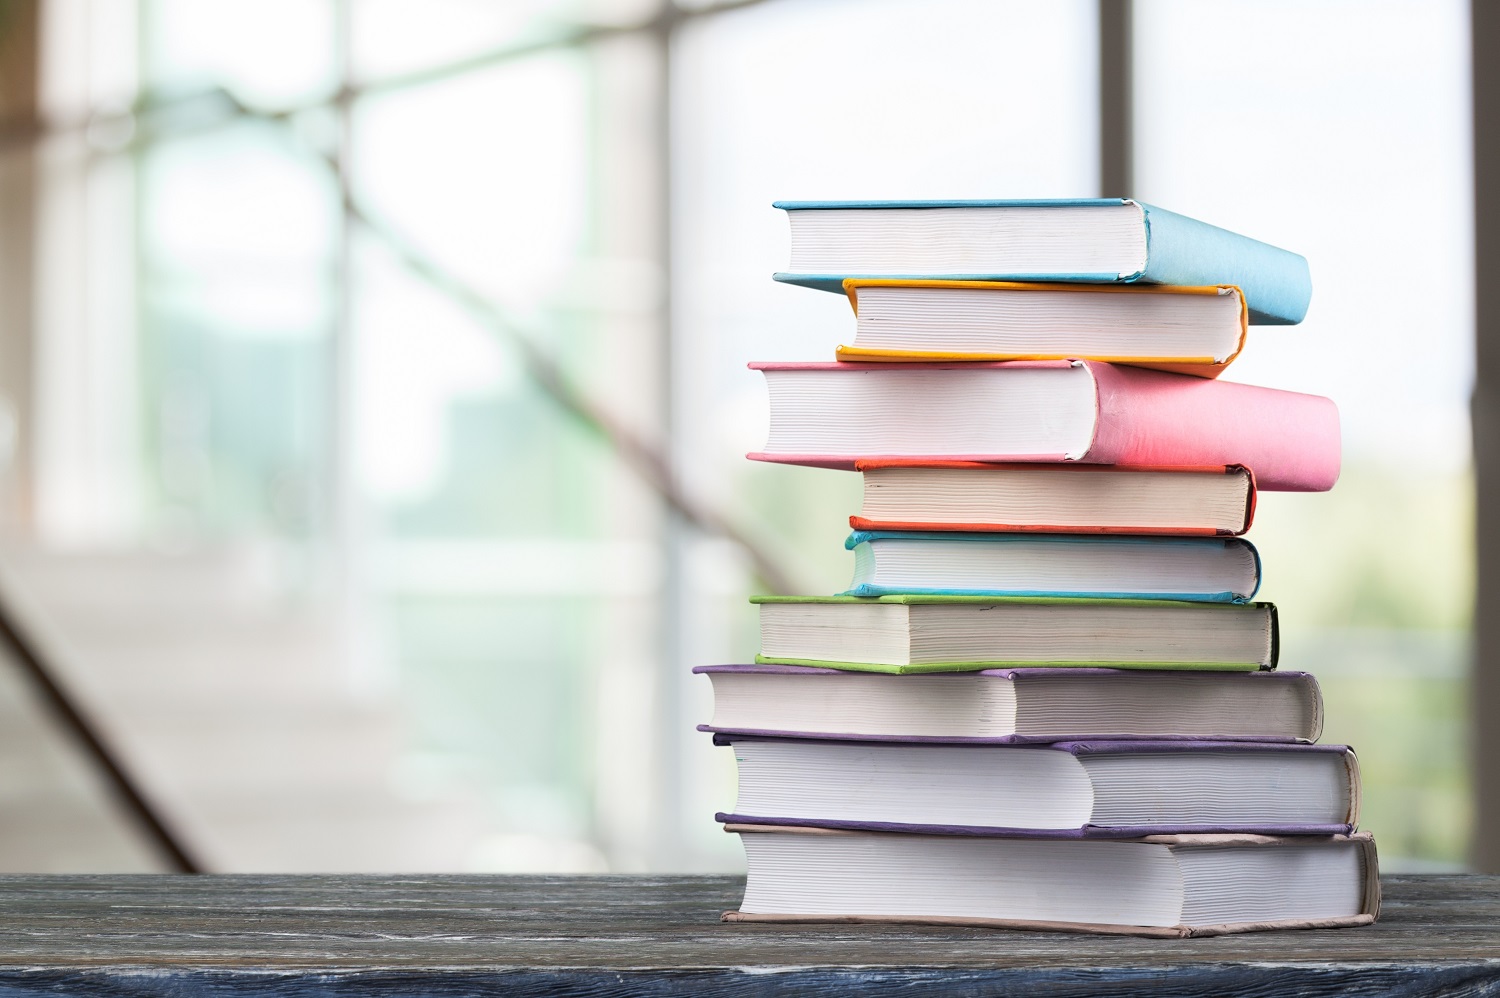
[774,198,1313,326]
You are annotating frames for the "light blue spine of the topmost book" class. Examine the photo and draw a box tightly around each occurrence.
[1139,204,1313,326]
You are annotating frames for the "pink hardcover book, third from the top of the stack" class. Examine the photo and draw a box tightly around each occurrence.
[750,360,1340,492]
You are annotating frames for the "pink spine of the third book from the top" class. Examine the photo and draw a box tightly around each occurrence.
[1082,362,1340,492]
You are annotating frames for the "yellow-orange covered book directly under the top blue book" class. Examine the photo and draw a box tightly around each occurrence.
[839,279,1250,378]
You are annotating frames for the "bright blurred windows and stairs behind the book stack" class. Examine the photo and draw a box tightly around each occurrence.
[0,0,1475,872]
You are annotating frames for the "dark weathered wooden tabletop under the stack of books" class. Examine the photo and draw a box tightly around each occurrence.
[0,876,1500,996]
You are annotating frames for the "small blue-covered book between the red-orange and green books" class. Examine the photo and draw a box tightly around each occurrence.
[845,530,1260,603]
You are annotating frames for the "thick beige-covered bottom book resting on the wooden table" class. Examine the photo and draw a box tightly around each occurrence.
[723,824,1380,936]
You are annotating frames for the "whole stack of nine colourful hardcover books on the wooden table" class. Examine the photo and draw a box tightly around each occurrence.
[696,200,1379,935]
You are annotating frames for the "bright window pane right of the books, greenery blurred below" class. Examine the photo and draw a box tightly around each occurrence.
[1136,0,1475,869]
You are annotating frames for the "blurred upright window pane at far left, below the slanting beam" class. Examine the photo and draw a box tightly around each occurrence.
[140,125,336,537]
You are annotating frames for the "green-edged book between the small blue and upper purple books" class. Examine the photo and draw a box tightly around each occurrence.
[752,596,1280,674]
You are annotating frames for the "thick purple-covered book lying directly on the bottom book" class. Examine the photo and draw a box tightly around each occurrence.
[714,734,1359,839]
